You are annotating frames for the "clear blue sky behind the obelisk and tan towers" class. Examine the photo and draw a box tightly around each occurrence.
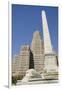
[12,4,58,55]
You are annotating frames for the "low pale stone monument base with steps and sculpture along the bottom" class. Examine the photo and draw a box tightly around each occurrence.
[16,69,58,85]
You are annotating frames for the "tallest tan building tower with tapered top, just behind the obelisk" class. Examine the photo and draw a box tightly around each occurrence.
[31,31,44,73]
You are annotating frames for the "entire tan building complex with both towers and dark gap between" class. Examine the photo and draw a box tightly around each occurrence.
[12,31,44,75]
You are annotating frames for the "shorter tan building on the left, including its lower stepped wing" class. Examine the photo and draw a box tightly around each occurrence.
[12,45,30,76]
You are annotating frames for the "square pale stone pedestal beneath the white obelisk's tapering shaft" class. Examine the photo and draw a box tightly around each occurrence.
[43,53,58,79]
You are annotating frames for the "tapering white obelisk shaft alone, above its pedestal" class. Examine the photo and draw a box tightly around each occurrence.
[42,11,52,54]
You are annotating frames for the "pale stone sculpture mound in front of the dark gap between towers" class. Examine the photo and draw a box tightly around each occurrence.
[21,69,41,82]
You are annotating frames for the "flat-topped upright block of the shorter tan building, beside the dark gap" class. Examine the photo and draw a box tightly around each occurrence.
[19,45,30,75]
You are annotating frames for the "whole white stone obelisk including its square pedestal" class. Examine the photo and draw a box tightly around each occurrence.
[41,10,57,78]
